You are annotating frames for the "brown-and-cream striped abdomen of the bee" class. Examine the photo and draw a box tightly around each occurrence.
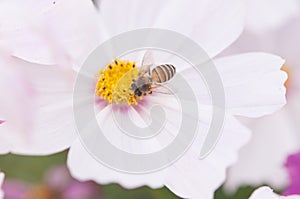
[151,64,176,83]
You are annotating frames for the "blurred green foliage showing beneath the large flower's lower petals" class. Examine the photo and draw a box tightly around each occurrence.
[0,151,254,199]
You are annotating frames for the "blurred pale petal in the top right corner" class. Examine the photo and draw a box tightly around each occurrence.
[245,0,300,33]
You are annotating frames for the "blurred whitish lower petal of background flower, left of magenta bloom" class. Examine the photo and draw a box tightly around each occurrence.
[225,101,300,191]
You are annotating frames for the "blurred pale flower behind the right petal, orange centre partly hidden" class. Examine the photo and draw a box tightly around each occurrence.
[224,4,300,190]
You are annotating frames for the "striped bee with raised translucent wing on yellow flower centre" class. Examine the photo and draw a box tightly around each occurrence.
[131,52,176,96]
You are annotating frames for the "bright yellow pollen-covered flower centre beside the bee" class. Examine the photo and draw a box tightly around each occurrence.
[95,59,142,105]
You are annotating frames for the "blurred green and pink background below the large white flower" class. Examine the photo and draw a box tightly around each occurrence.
[0,151,264,199]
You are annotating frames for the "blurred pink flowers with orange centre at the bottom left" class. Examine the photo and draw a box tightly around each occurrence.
[3,166,102,199]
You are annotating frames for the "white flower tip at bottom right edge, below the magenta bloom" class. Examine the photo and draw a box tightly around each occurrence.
[249,187,300,199]
